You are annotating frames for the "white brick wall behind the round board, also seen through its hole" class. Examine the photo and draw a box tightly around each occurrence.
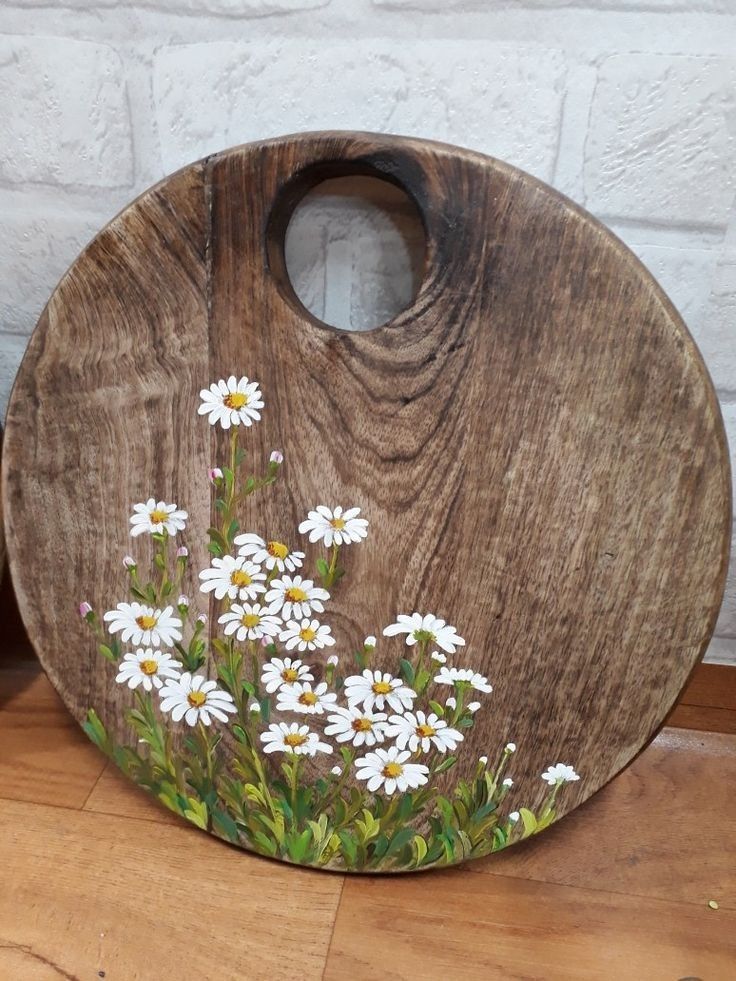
[0,0,736,663]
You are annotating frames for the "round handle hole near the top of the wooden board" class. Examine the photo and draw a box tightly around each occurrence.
[284,175,426,330]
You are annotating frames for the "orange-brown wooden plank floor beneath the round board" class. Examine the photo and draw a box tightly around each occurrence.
[0,580,736,981]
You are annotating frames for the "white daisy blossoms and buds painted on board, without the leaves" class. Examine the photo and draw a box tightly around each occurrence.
[87,376,579,804]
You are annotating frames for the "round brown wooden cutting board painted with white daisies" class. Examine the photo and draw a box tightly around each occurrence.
[3,133,730,871]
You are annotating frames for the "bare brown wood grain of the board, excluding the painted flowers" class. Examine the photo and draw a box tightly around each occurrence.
[3,134,730,872]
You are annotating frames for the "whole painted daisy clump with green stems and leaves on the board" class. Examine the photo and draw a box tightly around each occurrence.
[80,376,579,871]
